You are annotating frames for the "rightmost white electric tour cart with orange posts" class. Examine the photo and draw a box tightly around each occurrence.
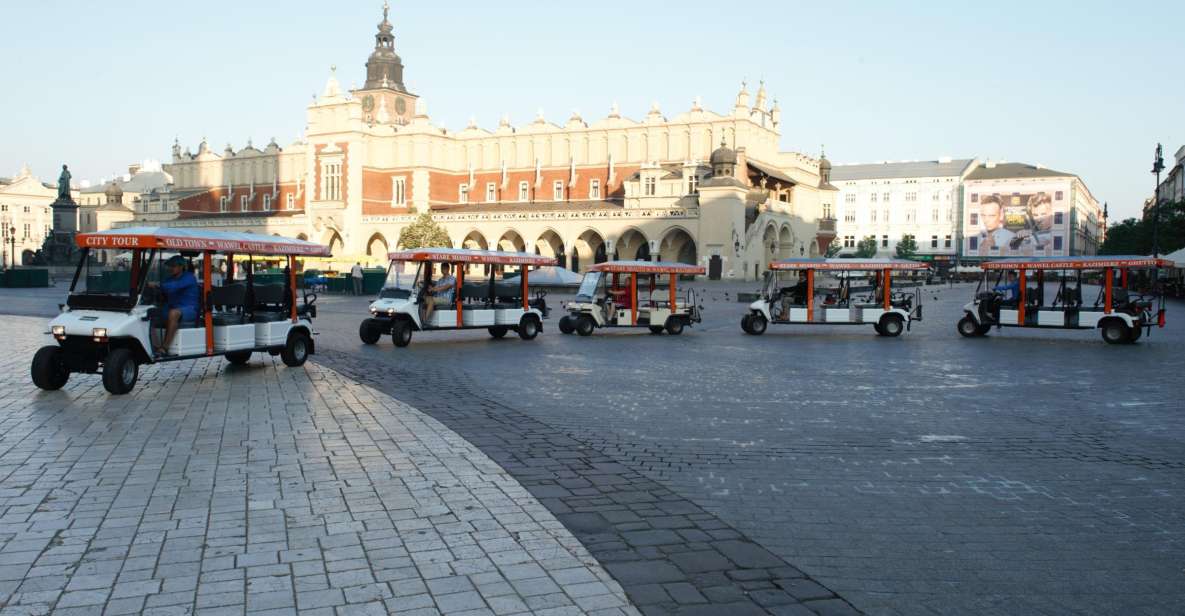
[957,256,1172,345]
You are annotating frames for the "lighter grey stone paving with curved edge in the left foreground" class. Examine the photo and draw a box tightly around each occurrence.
[0,316,636,616]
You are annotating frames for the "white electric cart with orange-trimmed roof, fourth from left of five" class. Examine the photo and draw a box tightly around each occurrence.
[741,258,928,338]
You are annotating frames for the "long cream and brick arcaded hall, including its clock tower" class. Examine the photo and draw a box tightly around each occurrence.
[136,8,838,280]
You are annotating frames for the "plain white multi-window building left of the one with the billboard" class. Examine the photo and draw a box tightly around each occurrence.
[831,159,976,265]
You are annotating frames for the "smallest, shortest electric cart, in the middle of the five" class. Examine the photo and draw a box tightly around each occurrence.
[559,261,705,335]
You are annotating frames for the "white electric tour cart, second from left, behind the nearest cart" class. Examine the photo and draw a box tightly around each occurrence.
[358,248,556,347]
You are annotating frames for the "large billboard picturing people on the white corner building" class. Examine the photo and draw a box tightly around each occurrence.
[971,192,1065,257]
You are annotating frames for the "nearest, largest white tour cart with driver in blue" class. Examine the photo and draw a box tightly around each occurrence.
[32,227,329,394]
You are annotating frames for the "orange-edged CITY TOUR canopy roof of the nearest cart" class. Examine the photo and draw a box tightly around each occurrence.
[76,226,329,257]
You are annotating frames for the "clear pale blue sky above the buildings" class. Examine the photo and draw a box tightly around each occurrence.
[0,0,1185,220]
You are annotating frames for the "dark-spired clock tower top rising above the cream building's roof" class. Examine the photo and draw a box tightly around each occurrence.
[354,2,417,126]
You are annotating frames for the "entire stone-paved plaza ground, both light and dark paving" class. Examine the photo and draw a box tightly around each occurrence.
[0,284,1185,615]
